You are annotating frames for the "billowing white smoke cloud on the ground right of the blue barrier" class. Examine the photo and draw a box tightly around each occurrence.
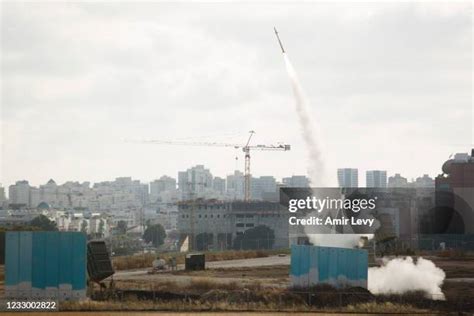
[368,257,446,300]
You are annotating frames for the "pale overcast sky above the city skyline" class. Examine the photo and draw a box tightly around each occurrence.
[0,2,473,186]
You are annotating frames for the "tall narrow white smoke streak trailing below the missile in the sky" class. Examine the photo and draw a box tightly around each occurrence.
[283,53,330,187]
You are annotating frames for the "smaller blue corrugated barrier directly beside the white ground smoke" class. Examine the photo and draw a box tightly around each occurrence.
[290,245,368,288]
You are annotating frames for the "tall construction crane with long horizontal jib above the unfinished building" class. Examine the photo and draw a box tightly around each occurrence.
[133,131,291,201]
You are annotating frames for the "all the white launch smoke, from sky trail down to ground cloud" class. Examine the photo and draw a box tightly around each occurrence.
[283,53,445,299]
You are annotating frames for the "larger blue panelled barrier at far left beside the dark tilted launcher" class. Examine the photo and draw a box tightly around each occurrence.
[5,232,86,301]
